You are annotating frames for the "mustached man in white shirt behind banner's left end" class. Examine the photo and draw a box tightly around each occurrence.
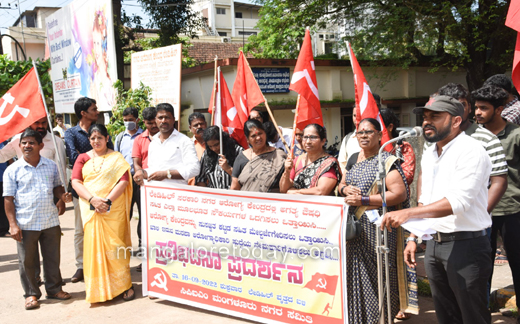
[144,103,200,184]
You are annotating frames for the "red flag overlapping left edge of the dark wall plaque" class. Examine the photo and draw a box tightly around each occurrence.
[231,51,265,120]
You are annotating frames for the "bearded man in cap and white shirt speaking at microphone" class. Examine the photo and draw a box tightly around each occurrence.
[381,95,492,324]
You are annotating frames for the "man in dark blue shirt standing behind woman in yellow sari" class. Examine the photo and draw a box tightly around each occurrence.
[65,97,114,283]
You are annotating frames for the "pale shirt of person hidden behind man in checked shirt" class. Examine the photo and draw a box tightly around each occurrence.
[0,132,67,183]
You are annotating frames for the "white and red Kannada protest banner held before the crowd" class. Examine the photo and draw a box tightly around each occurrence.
[141,182,348,323]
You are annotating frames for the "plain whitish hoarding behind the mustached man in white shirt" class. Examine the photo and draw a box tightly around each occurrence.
[131,44,182,121]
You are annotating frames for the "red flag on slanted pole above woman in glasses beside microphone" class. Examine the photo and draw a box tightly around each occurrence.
[348,45,392,152]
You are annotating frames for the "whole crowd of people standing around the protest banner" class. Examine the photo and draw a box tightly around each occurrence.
[0,75,520,323]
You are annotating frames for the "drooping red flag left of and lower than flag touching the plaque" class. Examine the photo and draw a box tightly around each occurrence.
[215,68,248,149]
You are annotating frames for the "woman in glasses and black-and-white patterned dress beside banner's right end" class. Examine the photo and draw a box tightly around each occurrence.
[338,118,409,323]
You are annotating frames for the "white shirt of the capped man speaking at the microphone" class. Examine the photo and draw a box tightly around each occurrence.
[419,133,491,233]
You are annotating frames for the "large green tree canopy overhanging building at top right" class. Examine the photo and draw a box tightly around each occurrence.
[246,0,515,89]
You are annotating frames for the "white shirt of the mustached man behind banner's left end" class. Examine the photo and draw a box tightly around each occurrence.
[146,129,200,184]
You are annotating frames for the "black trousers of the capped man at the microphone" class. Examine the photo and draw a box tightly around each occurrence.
[424,236,492,324]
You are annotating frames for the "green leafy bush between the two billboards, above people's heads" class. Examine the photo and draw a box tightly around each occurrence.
[107,80,152,138]
